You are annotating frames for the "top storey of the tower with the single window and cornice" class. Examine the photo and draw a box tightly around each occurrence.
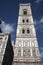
[19,3,32,16]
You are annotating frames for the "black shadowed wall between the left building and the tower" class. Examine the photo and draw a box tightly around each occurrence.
[2,36,14,65]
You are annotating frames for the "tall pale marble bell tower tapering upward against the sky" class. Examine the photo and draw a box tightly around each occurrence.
[13,3,41,65]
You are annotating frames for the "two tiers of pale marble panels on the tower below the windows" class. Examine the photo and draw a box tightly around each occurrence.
[14,38,38,57]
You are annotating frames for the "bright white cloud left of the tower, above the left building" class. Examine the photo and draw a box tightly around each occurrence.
[1,21,14,33]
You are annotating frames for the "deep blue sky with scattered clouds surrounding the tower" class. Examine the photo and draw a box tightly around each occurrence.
[0,0,43,62]
